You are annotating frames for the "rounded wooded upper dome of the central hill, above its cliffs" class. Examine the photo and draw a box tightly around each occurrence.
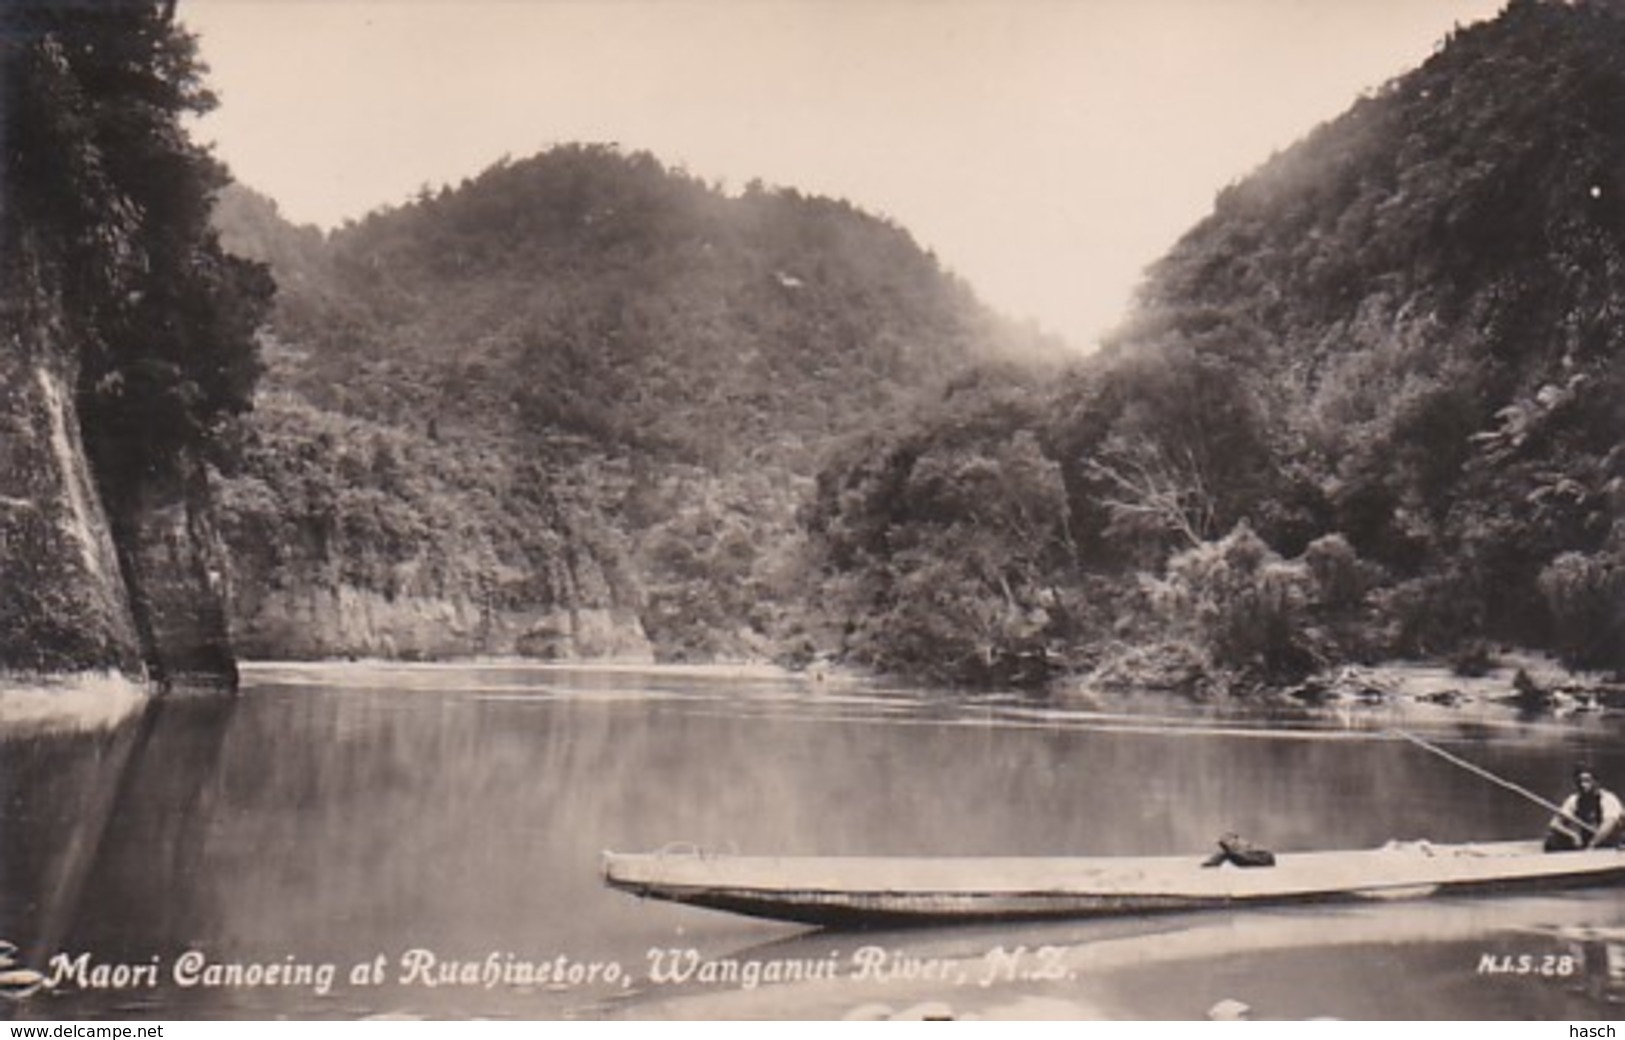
[216,145,1046,468]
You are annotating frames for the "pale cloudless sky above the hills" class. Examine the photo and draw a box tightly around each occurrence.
[180,0,1502,349]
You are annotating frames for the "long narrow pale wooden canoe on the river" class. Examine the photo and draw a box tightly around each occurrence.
[603,842,1625,928]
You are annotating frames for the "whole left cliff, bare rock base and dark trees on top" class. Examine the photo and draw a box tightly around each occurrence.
[0,0,271,695]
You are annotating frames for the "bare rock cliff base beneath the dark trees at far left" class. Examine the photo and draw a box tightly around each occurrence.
[0,261,237,687]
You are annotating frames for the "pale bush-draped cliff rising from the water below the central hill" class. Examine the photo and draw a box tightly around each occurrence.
[219,386,650,660]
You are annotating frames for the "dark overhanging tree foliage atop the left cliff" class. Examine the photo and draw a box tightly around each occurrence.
[3,0,273,515]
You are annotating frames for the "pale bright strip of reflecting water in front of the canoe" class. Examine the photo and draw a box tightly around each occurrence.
[605,892,1625,1019]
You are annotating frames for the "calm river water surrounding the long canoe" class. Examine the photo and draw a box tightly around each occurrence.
[0,665,1625,1019]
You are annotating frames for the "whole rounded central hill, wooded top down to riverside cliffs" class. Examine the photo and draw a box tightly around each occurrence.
[216,145,1058,657]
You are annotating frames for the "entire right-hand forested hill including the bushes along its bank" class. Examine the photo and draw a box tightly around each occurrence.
[813,0,1625,687]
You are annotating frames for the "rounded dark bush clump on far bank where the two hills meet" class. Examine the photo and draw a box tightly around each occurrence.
[808,380,1079,686]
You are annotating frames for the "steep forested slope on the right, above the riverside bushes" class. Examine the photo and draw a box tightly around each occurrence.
[1126,0,1625,666]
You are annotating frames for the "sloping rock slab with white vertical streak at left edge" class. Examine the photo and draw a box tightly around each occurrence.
[0,279,141,676]
